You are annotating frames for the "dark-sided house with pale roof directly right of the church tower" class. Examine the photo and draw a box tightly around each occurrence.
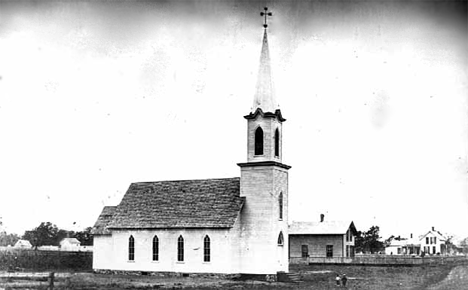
[289,215,357,263]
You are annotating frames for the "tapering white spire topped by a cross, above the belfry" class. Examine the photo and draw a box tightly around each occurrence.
[252,7,278,113]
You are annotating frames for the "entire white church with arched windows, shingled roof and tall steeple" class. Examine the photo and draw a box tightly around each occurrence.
[93,17,290,275]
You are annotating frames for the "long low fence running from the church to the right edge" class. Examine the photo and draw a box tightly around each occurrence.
[289,255,468,266]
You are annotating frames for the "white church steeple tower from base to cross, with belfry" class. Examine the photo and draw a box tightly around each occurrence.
[238,7,291,274]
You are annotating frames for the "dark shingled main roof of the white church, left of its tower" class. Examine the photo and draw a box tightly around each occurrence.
[107,178,245,229]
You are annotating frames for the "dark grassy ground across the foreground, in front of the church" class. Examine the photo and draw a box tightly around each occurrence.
[0,265,468,290]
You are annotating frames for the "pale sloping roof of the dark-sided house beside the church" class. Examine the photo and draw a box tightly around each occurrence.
[289,221,356,235]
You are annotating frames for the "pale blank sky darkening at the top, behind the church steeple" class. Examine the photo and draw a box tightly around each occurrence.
[0,1,468,237]
